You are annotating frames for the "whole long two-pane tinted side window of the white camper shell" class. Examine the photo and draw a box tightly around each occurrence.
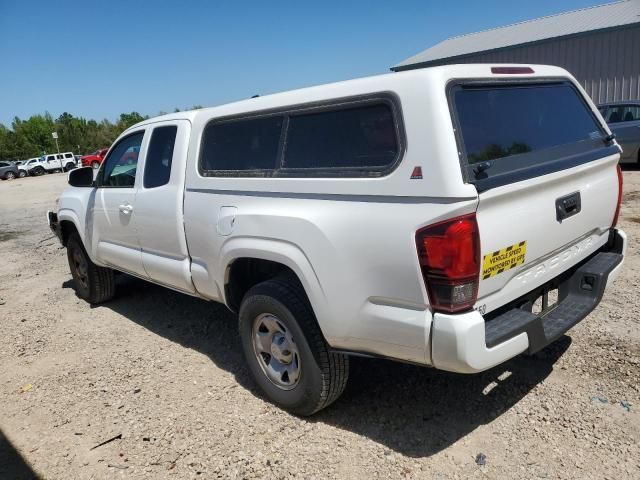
[200,94,402,177]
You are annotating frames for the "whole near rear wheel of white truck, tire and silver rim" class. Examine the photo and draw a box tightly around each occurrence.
[239,277,349,416]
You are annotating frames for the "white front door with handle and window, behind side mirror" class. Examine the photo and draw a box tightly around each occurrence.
[92,129,147,277]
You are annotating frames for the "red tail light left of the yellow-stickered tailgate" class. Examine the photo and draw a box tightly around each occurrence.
[416,214,480,313]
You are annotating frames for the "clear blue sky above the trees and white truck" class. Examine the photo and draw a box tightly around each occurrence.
[0,0,603,126]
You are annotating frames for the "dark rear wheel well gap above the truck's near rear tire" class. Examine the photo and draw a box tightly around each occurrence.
[224,258,304,312]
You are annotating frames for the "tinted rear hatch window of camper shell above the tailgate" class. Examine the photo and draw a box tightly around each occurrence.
[449,81,615,187]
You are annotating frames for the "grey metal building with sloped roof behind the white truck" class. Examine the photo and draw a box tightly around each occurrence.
[391,0,640,103]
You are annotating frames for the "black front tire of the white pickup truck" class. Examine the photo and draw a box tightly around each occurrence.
[67,233,115,304]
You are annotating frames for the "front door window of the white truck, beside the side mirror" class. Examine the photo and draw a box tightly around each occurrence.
[96,131,144,188]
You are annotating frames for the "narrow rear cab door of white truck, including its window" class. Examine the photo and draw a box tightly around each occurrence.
[135,120,195,293]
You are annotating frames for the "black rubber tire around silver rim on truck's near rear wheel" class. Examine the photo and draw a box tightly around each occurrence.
[239,276,349,416]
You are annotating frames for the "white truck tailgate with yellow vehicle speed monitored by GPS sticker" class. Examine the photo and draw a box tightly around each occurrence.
[477,159,618,312]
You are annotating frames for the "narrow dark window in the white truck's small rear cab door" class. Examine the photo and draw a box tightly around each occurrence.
[144,125,178,188]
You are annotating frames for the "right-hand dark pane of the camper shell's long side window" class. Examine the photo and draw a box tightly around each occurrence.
[283,104,398,170]
